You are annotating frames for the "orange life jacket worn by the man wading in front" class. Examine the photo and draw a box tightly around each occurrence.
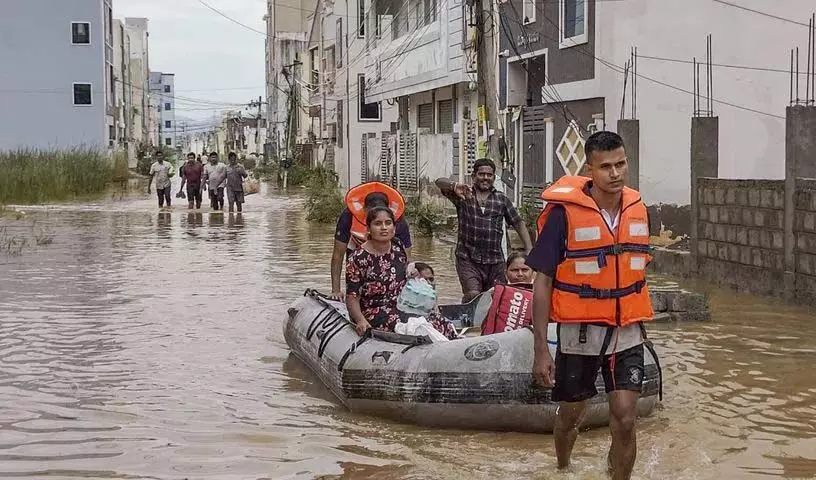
[538,176,654,326]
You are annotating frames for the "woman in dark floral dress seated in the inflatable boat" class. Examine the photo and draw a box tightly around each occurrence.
[346,207,455,338]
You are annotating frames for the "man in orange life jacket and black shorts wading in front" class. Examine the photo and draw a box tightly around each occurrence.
[527,132,653,480]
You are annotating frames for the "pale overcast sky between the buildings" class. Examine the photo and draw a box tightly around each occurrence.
[113,0,266,125]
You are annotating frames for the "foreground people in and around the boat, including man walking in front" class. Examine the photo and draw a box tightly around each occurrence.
[331,131,654,480]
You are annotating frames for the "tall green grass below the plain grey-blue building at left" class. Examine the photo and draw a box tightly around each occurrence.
[0,148,119,204]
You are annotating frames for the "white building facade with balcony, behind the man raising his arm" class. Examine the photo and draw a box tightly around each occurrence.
[358,0,484,199]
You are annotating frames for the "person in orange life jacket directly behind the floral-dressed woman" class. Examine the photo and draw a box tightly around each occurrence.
[331,182,411,300]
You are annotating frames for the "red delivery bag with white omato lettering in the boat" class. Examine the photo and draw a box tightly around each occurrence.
[482,284,533,335]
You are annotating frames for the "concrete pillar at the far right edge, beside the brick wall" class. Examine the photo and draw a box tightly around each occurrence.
[784,105,816,298]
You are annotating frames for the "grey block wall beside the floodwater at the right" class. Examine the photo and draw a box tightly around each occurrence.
[692,178,816,304]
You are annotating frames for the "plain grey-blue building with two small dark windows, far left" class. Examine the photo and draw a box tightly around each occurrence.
[0,0,116,151]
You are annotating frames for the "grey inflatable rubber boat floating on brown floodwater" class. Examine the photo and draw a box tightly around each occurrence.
[284,290,662,432]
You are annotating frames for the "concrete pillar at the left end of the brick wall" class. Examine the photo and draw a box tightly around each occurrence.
[690,117,720,272]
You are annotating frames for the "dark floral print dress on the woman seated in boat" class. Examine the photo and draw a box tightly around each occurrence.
[346,242,456,339]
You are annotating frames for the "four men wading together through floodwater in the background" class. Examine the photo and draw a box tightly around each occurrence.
[147,150,247,212]
